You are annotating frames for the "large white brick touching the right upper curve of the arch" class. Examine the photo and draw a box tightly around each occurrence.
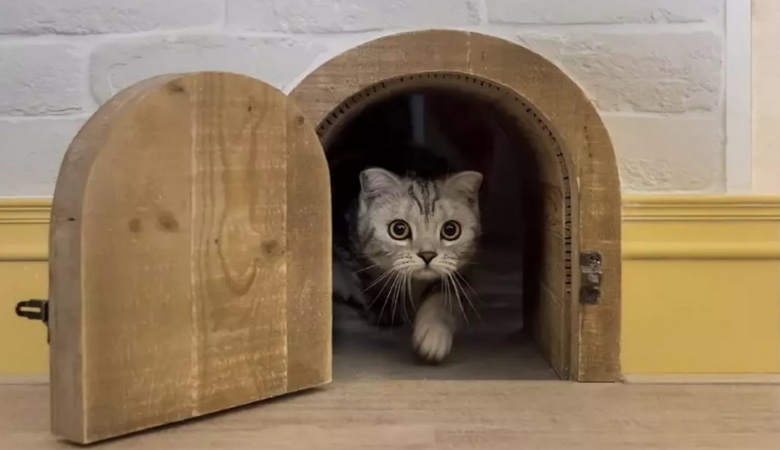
[519,31,723,113]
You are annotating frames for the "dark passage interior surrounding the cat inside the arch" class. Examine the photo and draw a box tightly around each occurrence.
[320,87,557,381]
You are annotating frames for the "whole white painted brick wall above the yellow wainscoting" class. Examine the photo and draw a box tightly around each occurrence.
[0,0,727,196]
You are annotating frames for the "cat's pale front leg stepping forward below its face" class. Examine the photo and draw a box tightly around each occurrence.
[412,289,458,362]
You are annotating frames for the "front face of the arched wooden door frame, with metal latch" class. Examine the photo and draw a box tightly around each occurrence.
[290,30,621,381]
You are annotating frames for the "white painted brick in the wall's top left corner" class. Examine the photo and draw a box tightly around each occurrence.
[0,0,225,34]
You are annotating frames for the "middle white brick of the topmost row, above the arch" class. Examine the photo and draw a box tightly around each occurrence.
[227,0,481,33]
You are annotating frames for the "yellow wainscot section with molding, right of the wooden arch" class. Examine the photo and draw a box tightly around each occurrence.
[621,195,780,375]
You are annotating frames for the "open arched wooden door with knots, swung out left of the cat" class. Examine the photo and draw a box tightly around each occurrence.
[50,72,331,443]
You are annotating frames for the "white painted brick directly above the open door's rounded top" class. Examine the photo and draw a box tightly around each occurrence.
[90,34,325,103]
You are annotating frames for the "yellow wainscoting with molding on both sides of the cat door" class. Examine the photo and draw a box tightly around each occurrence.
[0,195,780,380]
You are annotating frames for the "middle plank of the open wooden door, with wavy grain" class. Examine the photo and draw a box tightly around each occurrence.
[190,74,287,414]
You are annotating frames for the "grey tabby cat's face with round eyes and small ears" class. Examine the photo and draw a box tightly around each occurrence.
[358,169,482,279]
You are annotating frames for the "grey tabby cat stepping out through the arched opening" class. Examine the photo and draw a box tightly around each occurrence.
[333,163,483,362]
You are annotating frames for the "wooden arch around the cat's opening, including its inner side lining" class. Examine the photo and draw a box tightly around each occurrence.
[290,30,621,381]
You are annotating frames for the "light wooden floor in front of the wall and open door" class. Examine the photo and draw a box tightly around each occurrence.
[0,380,780,450]
